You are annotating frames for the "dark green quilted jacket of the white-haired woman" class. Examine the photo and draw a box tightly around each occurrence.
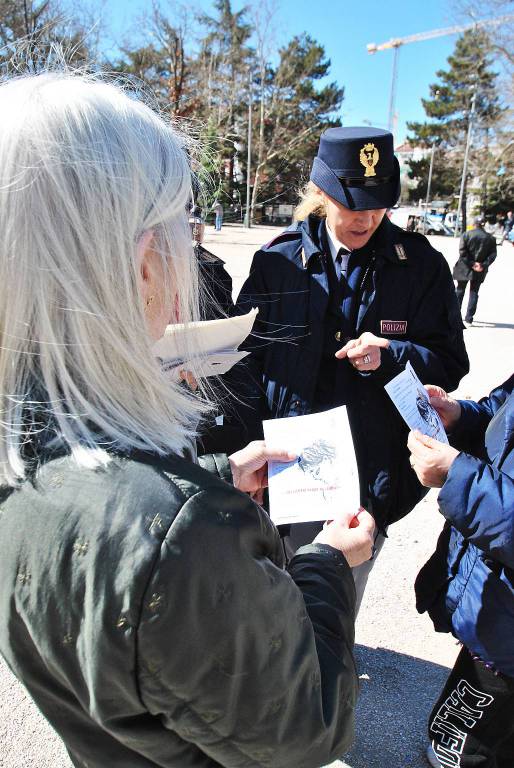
[0,455,357,768]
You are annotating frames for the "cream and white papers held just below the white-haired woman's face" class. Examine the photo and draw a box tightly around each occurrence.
[153,309,259,377]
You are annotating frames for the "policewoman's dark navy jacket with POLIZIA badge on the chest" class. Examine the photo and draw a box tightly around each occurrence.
[236,216,469,528]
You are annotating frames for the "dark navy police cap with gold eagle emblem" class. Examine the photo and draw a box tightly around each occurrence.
[311,127,400,211]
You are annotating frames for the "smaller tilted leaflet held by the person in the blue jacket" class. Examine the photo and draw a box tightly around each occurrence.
[385,363,448,443]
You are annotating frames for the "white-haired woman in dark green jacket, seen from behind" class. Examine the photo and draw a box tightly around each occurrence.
[0,74,372,768]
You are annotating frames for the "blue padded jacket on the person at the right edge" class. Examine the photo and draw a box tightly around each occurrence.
[416,376,514,677]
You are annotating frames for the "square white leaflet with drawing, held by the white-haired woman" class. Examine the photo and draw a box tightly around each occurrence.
[263,406,360,525]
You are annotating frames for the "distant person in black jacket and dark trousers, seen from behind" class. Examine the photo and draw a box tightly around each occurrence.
[453,218,496,326]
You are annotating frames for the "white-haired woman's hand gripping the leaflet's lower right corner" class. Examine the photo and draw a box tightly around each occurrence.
[314,508,375,568]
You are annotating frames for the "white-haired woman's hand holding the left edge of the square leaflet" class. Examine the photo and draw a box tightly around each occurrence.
[228,440,298,504]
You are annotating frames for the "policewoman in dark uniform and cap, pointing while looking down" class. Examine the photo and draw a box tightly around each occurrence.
[237,127,469,606]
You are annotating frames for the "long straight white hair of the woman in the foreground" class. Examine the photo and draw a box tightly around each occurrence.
[0,73,205,485]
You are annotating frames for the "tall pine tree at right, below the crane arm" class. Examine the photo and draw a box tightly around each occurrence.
[408,30,502,227]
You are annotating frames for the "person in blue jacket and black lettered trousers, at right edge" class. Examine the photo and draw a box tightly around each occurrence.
[409,375,514,768]
